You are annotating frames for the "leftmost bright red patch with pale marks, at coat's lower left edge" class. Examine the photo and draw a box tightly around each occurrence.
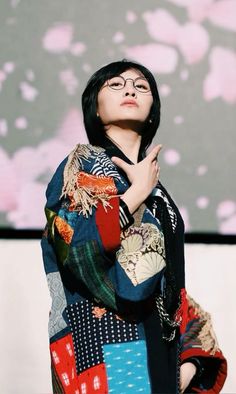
[50,334,79,394]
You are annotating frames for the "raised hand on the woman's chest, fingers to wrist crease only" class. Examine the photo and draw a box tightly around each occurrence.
[111,145,162,199]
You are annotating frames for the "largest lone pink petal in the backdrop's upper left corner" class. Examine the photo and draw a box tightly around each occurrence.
[43,23,73,53]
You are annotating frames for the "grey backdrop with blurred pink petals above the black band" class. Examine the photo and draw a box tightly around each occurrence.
[0,0,236,234]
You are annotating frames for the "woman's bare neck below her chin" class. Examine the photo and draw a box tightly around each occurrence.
[106,125,141,163]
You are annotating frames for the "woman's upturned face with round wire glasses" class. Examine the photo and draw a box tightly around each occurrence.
[97,69,153,127]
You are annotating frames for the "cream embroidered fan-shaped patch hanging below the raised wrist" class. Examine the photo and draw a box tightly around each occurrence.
[116,223,166,286]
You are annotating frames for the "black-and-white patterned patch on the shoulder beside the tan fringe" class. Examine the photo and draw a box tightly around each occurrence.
[91,152,126,185]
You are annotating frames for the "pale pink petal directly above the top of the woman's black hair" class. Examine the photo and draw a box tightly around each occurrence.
[124,44,178,74]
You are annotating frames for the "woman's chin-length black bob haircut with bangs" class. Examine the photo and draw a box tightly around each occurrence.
[82,59,161,153]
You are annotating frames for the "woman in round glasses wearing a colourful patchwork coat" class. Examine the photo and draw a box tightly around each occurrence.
[42,61,226,394]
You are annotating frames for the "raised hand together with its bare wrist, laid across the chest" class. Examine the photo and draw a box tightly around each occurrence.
[111,145,162,214]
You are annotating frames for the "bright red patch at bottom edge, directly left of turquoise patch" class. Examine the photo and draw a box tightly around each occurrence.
[77,363,108,394]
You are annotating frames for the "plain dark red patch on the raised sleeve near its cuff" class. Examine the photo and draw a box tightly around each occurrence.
[96,197,120,251]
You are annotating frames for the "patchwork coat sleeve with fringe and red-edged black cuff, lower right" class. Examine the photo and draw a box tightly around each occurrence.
[180,295,227,394]
